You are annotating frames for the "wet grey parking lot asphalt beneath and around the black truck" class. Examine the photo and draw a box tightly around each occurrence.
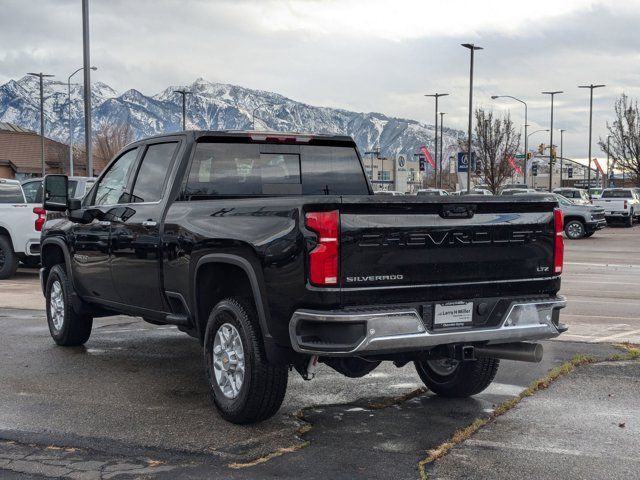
[0,226,640,479]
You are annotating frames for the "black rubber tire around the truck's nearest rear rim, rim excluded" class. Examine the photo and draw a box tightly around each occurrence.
[204,297,289,424]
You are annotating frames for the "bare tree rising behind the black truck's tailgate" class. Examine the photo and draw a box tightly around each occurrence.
[473,108,520,194]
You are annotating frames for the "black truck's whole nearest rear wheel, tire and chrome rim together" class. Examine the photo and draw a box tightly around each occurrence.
[204,297,288,424]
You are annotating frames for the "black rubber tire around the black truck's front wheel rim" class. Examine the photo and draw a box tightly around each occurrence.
[45,265,93,347]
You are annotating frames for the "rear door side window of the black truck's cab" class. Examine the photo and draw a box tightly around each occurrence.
[131,142,178,202]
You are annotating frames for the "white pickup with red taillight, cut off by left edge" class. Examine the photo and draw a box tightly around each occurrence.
[0,178,45,279]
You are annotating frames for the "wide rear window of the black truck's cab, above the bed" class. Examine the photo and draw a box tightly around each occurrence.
[185,143,369,197]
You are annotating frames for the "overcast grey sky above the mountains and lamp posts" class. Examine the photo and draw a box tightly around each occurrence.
[0,0,640,162]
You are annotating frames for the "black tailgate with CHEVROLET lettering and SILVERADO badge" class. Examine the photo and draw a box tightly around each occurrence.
[339,195,557,289]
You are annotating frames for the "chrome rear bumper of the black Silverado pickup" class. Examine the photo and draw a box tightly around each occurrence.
[289,296,566,356]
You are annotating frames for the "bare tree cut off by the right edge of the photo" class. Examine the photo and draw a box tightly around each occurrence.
[598,93,640,186]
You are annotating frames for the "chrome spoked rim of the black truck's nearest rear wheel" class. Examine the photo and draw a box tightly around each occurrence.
[213,323,244,399]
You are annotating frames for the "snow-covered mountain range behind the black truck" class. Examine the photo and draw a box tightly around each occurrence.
[0,76,464,156]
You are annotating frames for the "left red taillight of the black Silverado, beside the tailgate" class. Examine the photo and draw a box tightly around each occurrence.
[305,210,340,285]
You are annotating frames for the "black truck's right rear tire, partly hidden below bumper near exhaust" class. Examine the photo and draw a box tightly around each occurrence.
[415,358,500,398]
